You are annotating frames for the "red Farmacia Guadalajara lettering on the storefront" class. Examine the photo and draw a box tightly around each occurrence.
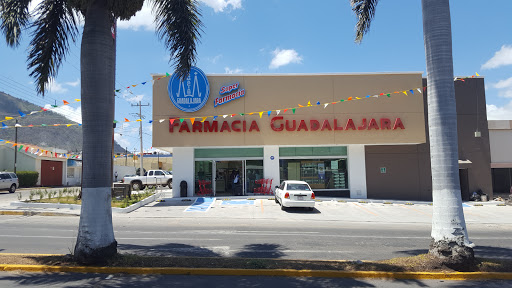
[169,116,405,133]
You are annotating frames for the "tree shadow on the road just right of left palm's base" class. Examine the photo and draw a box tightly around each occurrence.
[118,243,222,257]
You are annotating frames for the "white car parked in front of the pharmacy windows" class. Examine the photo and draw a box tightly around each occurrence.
[275,180,315,211]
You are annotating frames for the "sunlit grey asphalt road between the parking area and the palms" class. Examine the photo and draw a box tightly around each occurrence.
[0,215,512,260]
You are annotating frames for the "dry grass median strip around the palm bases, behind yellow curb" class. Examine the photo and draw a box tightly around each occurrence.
[0,254,512,272]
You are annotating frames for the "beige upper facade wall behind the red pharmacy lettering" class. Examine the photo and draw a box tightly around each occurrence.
[153,73,425,148]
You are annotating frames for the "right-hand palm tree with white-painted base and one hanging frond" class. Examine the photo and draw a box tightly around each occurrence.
[351,0,474,264]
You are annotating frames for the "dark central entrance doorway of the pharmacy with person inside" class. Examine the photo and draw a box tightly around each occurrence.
[214,160,245,196]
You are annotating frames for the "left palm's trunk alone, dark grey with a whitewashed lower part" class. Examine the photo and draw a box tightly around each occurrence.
[75,0,117,263]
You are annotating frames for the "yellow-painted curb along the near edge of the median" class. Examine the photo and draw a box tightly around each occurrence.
[0,264,512,280]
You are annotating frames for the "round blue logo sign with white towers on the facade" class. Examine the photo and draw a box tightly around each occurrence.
[167,66,210,112]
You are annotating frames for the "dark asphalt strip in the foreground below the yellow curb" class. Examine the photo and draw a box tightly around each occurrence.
[0,272,512,288]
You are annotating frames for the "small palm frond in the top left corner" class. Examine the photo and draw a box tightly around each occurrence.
[0,0,31,47]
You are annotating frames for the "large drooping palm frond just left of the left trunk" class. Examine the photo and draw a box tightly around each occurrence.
[28,0,78,95]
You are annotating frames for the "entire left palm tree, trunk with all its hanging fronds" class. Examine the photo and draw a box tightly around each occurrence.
[0,0,202,262]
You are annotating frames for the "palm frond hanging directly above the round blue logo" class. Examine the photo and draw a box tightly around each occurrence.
[153,0,203,79]
